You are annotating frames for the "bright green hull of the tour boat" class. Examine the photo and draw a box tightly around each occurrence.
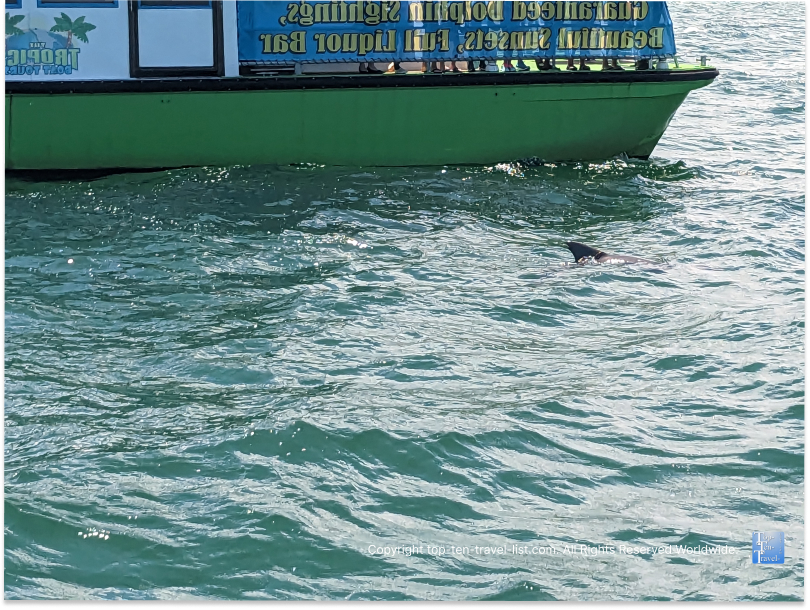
[6,74,714,170]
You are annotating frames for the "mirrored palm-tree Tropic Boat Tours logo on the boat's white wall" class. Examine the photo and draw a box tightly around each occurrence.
[6,13,96,76]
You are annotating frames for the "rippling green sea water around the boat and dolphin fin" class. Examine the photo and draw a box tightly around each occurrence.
[4,3,805,600]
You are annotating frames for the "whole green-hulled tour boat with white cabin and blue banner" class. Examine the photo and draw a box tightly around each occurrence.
[5,0,718,171]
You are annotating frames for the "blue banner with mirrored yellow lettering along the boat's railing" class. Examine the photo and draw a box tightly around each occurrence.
[237,0,675,64]
